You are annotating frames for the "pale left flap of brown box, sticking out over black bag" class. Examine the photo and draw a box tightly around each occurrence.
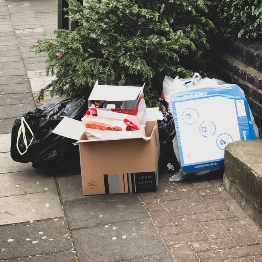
[53,117,85,140]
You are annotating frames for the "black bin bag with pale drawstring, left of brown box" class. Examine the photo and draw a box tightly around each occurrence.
[11,97,88,171]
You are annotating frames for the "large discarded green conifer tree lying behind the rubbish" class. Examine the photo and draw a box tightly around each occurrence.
[34,0,213,106]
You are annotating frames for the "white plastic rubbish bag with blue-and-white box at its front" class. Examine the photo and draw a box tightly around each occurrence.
[162,73,258,181]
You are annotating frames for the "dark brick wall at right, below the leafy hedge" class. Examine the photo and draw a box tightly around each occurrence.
[213,40,262,137]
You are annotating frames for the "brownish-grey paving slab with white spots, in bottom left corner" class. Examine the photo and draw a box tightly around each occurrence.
[0,218,72,261]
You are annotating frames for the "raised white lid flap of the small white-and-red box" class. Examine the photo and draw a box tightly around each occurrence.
[88,83,144,101]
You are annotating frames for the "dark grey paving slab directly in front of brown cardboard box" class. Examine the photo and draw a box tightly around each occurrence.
[63,194,148,229]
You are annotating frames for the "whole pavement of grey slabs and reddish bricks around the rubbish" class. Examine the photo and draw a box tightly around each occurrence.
[0,0,262,262]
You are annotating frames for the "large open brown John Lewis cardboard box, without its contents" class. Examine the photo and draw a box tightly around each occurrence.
[53,109,160,195]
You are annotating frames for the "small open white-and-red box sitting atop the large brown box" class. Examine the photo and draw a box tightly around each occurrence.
[88,82,147,126]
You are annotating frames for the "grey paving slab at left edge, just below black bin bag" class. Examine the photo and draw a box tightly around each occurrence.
[0,170,57,197]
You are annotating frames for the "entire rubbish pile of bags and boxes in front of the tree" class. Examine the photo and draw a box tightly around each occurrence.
[11,73,258,195]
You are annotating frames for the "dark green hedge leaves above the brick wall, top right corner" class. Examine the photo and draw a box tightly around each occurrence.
[211,0,262,41]
